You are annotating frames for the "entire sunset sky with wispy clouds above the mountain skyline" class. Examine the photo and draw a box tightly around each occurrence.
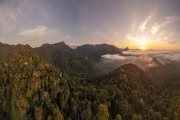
[0,0,180,50]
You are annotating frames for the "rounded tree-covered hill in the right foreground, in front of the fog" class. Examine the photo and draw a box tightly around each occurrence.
[71,64,172,120]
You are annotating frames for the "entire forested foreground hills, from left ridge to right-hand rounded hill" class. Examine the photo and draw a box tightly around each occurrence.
[0,43,180,120]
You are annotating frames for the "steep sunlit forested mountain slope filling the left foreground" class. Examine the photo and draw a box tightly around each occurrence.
[0,46,69,120]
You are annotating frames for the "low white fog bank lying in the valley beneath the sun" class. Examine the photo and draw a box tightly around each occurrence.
[96,50,180,73]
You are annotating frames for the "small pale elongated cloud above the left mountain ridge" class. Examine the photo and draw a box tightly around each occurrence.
[20,26,56,37]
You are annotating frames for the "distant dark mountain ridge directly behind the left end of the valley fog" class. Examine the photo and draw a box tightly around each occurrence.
[75,44,122,61]
